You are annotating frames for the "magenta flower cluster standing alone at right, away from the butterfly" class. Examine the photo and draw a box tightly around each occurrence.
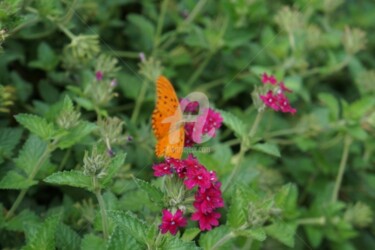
[260,73,297,114]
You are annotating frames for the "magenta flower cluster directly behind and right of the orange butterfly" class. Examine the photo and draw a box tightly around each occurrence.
[180,98,223,147]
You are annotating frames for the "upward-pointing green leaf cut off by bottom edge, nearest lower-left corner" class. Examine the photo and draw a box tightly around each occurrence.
[23,215,60,250]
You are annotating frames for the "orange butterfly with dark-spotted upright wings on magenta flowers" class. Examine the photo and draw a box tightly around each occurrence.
[152,76,185,159]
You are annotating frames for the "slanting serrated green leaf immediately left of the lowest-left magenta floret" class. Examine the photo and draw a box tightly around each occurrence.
[108,211,148,246]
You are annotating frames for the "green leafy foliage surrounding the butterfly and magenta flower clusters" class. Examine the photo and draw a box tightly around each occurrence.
[0,0,375,250]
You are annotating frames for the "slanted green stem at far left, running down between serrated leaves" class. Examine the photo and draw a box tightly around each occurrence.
[5,141,56,219]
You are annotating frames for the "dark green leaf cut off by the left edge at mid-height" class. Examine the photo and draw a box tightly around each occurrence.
[0,128,22,164]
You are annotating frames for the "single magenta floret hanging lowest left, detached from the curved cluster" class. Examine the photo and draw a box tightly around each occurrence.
[159,209,187,235]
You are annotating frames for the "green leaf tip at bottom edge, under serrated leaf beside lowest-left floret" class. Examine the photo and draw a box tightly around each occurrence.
[106,226,144,250]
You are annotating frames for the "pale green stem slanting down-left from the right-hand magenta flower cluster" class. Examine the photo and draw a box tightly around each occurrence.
[222,111,263,193]
